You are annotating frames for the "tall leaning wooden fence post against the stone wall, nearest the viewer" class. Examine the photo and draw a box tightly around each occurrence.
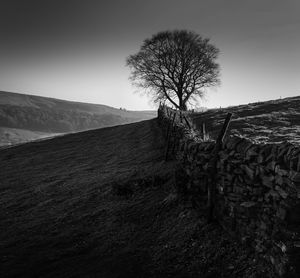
[207,113,232,223]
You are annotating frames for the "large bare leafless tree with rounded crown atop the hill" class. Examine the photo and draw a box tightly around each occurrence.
[126,30,219,110]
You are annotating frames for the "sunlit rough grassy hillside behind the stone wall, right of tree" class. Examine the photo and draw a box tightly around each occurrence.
[191,96,300,143]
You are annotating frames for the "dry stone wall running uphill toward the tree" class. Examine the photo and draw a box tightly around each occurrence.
[158,106,300,275]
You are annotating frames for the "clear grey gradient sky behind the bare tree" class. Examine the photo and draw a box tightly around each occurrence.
[0,0,300,110]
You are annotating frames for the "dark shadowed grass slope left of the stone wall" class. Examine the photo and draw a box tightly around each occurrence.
[0,120,274,278]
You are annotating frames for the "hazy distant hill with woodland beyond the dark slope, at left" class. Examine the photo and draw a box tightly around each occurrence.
[0,92,156,146]
